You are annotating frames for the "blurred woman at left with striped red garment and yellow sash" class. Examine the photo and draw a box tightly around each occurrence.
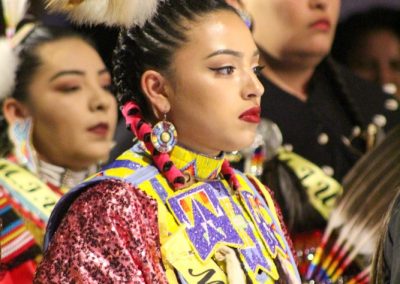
[0,19,117,283]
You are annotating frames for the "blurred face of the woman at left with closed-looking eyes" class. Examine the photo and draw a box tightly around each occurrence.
[27,38,117,169]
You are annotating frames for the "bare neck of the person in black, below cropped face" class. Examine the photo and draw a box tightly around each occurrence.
[260,53,316,101]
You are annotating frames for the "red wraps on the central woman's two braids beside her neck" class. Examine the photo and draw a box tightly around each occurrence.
[121,101,239,190]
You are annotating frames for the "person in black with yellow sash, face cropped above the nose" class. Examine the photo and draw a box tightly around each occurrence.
[227,0,400,276]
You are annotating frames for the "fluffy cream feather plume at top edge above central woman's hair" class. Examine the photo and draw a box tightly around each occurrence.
[46,0,164,27]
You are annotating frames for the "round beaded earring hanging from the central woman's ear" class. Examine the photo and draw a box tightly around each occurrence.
[151,114,178,153]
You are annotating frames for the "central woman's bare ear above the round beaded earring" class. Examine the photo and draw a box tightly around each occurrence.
[141,70,171,119]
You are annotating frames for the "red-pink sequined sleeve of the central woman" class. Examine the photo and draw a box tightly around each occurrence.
[34,180,168,284]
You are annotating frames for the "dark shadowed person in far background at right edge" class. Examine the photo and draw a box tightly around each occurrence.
[332,8,400,98]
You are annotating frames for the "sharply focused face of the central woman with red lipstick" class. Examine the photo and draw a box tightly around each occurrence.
[167,11,264,155]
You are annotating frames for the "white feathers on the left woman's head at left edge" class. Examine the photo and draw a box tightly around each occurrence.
[0,0,28,100]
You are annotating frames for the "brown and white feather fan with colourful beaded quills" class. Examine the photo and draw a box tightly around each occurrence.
[307,126,400,283]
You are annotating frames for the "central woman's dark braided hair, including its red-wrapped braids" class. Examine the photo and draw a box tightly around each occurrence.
[113,0,239,189]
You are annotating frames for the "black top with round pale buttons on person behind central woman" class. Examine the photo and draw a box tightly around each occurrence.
[261,59,400,181]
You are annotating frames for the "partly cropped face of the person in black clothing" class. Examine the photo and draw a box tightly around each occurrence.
[243,0,340,60]
